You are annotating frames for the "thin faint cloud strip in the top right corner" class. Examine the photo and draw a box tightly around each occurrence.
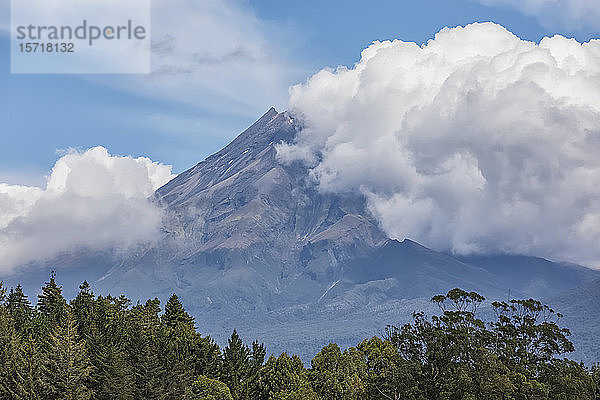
[478,0,600,30]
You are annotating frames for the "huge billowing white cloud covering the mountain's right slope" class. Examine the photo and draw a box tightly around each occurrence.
[278,23,600,264]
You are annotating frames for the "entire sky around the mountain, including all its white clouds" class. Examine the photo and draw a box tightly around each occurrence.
[0,0,600,270]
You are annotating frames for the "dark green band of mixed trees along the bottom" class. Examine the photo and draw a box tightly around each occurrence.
[0,273,600,400]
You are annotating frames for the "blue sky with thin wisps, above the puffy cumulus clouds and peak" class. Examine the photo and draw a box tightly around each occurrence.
[0,0,600,185]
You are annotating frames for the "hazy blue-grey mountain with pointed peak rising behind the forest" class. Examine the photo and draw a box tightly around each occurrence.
[4,108,600,359]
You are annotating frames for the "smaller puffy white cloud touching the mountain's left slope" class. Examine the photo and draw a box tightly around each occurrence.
[0,147,173,273]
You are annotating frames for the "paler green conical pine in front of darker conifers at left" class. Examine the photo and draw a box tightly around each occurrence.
[43,313,92,400]
